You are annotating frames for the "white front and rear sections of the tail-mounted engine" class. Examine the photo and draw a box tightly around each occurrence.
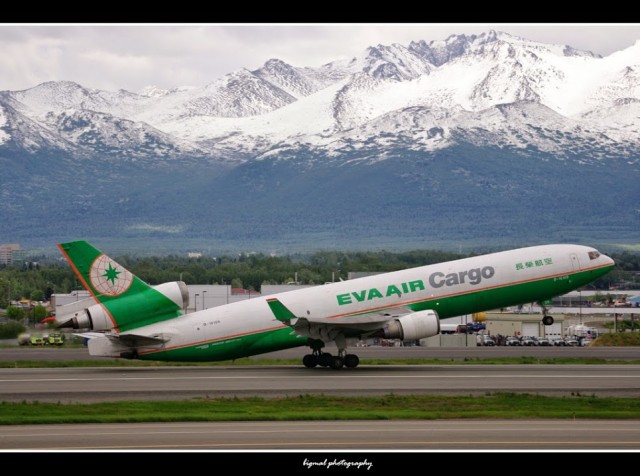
[58,281,189,331]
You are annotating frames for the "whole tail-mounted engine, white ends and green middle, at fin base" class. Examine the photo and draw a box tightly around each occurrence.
[58,281,189,331]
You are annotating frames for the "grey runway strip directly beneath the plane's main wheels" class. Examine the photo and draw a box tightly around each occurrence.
[0,365,640,403]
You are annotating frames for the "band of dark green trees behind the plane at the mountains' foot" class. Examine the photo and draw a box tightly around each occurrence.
[0,250,640,309]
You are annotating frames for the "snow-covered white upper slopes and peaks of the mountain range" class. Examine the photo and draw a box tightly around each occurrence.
[0,31,640,160]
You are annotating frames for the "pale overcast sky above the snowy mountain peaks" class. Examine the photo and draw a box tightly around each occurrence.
[0,23,640,92]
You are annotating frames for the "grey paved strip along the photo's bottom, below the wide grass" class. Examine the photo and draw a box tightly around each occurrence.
[0,420,640,450]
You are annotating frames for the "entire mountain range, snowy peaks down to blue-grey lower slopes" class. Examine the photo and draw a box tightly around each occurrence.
[0,31,640,255]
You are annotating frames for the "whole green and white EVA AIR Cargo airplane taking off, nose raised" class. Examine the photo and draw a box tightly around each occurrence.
[58,241,615,369]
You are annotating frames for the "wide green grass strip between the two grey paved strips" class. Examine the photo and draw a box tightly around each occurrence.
[0,393,640,425]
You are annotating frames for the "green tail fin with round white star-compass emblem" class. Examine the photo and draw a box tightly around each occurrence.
[58,241,182,331]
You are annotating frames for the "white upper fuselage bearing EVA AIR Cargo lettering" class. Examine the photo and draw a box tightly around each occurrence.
[116,244,613,356]
